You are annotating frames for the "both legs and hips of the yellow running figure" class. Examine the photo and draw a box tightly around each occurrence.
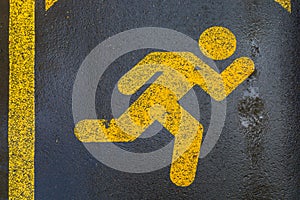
[75,84,203,186]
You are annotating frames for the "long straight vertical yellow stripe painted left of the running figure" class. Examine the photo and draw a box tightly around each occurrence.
[8,0,35,199]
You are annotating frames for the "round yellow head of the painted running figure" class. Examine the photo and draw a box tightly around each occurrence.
[199,26,236,60]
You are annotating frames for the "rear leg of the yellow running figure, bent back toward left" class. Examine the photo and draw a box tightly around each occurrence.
[74,84,180,142]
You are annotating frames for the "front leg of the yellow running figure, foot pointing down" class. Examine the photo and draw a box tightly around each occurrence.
[155,107,203,187]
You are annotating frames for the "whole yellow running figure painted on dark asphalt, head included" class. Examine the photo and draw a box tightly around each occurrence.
[75,26,255,186]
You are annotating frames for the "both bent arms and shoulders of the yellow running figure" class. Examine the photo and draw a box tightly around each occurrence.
[118,52,255,101]
